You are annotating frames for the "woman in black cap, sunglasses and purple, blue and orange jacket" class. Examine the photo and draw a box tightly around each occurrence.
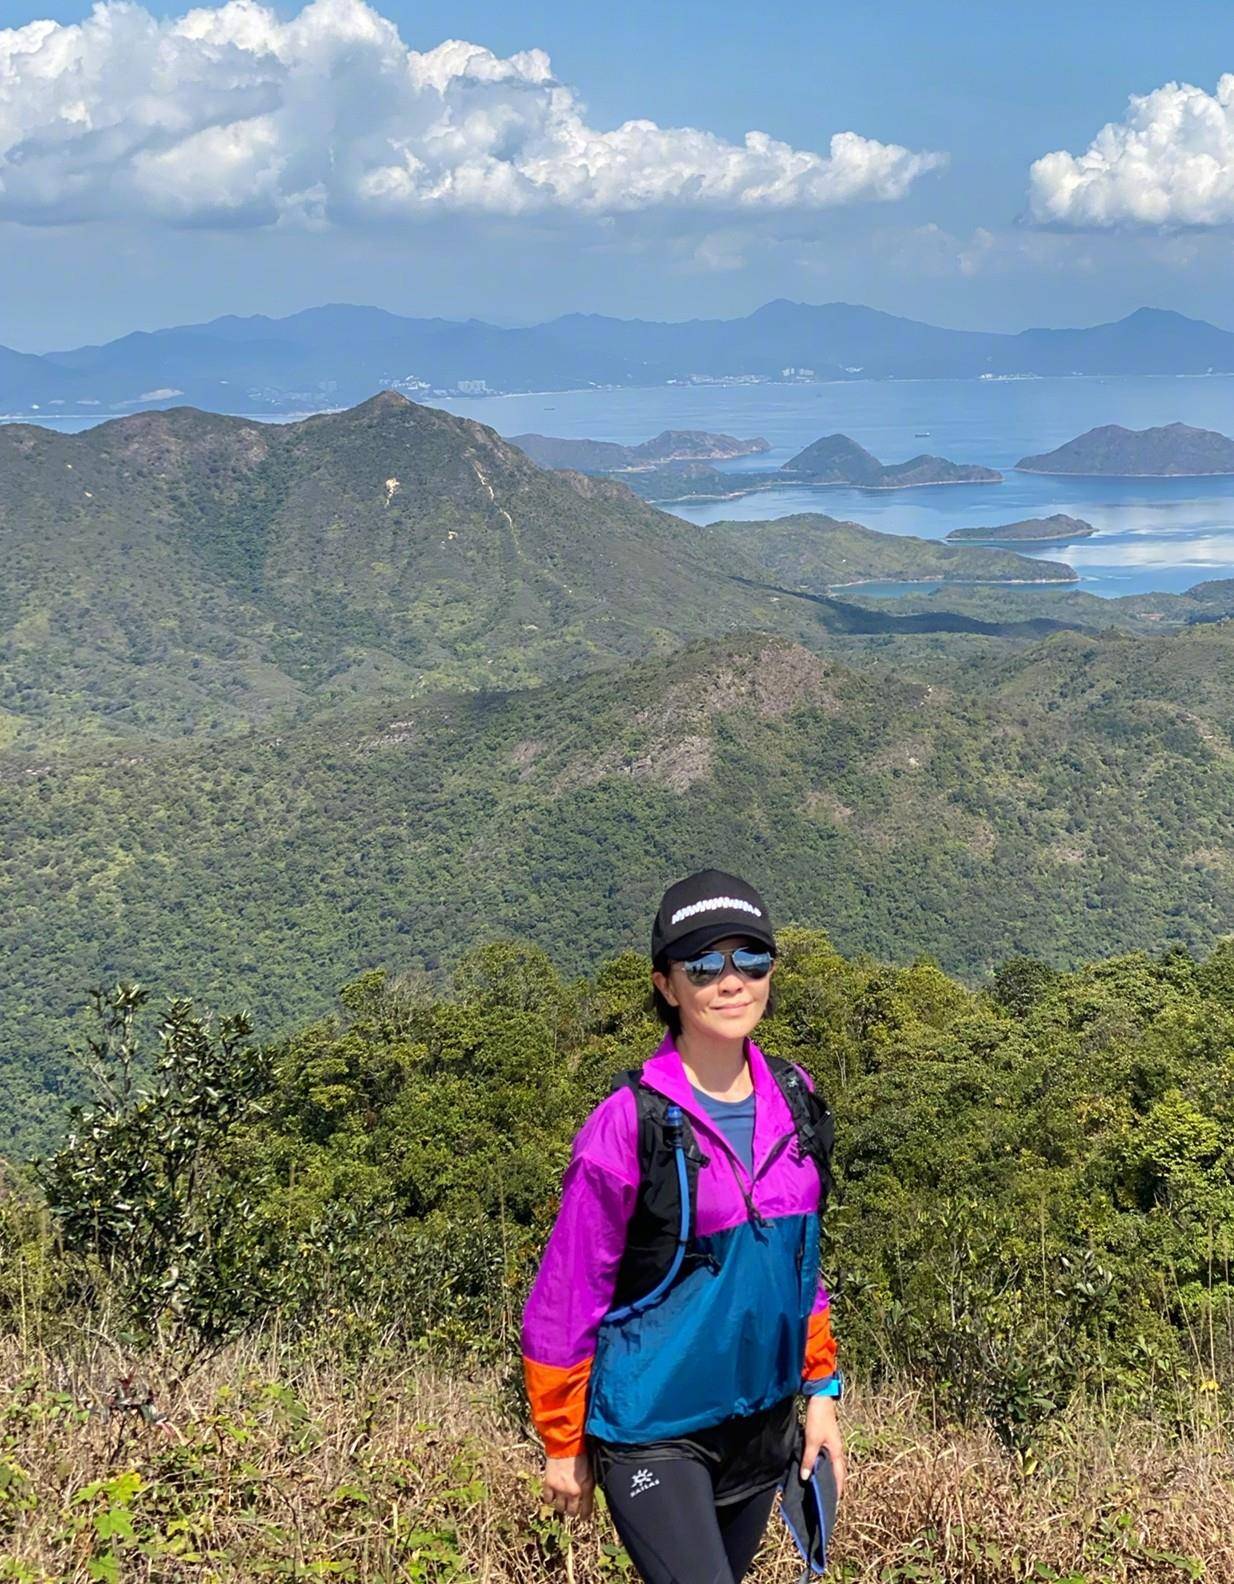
[523,870,844,1584]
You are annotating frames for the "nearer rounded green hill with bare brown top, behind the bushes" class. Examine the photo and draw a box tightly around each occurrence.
[0,624,1234,1159]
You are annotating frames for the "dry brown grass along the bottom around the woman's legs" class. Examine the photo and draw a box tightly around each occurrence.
[0,1342,1234,1584]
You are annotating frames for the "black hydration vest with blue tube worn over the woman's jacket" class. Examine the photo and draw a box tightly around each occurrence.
[605,1057,835,1321]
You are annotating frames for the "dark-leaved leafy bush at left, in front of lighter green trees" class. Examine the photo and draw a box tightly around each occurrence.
[38,984,277,1346]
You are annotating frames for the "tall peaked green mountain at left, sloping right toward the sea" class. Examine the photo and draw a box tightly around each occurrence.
[0,393,1057,752]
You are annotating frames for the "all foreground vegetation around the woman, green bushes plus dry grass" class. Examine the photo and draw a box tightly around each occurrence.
[0,928,1234,1584]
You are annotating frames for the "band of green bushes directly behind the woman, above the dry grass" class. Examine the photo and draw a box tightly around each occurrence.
[16,928,1234,1450]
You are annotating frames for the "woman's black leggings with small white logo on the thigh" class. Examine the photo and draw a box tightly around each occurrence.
[604,1449,776,1584]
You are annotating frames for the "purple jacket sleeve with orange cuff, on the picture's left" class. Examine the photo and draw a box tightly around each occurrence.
[523,1090,638,1457]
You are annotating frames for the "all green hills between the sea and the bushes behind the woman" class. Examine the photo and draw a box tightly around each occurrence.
[0,396,1234,1165]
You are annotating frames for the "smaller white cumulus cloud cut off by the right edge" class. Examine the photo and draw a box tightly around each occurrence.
[1030,73,1234,227]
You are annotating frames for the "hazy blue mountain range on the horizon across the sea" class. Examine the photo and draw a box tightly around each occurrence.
[0,301,1234,415]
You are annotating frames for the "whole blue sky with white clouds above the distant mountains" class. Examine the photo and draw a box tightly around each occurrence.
[0,0,1234,352]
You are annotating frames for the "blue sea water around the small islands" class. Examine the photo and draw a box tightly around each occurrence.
[25,375,1234,596]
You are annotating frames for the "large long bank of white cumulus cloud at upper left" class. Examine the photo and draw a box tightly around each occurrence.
[0,0,943,227]
